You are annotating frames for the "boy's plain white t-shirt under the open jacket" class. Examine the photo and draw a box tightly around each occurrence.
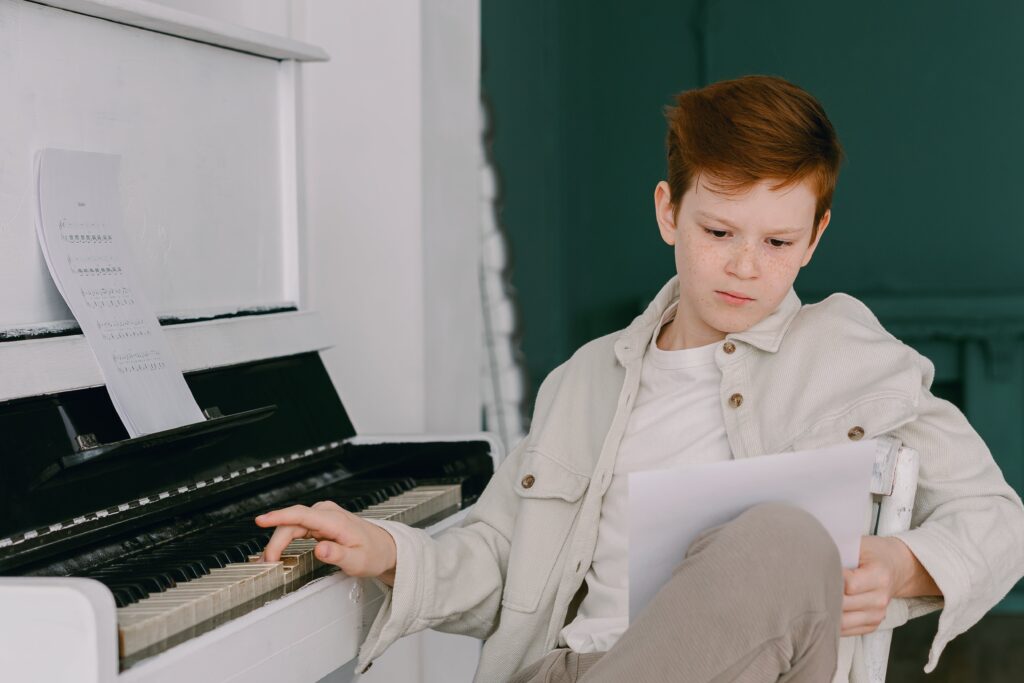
[560,305,732,652]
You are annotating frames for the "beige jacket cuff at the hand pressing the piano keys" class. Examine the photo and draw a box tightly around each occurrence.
[356,519,424,672]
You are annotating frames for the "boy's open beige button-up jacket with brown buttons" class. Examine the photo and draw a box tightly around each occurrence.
[359,279,1024,683]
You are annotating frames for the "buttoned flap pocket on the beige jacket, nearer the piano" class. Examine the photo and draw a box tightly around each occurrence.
[502,450,590,612]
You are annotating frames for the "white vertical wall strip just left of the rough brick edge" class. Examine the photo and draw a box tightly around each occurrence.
[420,0,483,432]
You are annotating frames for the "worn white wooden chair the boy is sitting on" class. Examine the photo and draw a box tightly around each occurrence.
[862,437,919,683]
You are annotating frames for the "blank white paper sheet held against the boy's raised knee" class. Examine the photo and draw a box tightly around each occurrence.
[629,440,880,621]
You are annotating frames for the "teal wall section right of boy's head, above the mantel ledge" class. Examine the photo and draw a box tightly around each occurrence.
[708,0,1024,294]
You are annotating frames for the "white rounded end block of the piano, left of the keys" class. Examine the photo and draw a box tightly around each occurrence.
[0,577,118,683]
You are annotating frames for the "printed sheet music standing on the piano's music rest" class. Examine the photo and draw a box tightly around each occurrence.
[36,150,203,436]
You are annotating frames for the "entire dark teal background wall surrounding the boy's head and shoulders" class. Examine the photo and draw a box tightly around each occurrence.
[482,0,1024,607]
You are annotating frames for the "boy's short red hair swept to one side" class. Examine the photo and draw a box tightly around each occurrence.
[666,76,843,237]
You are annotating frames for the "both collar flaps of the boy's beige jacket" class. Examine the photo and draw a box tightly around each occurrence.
[615,276,801,366]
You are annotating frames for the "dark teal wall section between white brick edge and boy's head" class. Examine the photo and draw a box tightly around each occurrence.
[482,0,697,391]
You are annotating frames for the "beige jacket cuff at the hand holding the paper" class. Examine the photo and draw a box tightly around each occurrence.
[893,526,971,674]
